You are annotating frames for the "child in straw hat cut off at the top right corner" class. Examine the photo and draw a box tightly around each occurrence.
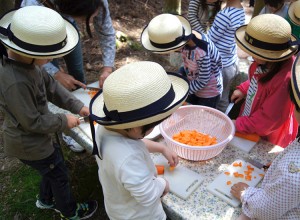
[286,1,300,39]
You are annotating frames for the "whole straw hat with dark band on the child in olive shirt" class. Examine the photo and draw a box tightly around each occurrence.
[0,6,79,59]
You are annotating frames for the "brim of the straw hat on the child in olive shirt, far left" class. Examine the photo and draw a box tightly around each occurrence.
[0,10,79,59]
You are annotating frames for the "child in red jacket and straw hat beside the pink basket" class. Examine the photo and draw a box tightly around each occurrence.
[231,14,298,147]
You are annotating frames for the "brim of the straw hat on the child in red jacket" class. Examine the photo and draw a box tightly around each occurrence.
[235,25,298,62]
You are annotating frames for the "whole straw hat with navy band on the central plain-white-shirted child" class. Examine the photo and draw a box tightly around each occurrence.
[90,61,189,129]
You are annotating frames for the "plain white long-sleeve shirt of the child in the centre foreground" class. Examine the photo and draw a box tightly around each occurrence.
[96,126,166,220]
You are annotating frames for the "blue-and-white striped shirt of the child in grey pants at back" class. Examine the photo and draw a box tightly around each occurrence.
[208,7,245,67]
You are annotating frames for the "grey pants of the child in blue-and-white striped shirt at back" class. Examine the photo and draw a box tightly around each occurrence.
[217,64,239,112]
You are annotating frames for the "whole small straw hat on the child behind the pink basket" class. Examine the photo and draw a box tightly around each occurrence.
[141,14,192,53]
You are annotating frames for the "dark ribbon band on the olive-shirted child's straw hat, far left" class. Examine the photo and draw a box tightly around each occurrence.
[0,25,67,53]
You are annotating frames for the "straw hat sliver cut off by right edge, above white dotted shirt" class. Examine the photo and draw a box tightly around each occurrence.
[291,56,300,108]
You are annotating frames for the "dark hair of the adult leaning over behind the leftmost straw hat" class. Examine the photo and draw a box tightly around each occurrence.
[40,0,107,38]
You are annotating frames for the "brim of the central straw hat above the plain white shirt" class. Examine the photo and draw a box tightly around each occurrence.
[90,73,189,129]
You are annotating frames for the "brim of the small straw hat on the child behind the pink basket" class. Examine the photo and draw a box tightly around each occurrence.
[140,15,192,53]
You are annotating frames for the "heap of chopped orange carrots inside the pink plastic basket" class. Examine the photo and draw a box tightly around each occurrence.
[173,130,217,146]
